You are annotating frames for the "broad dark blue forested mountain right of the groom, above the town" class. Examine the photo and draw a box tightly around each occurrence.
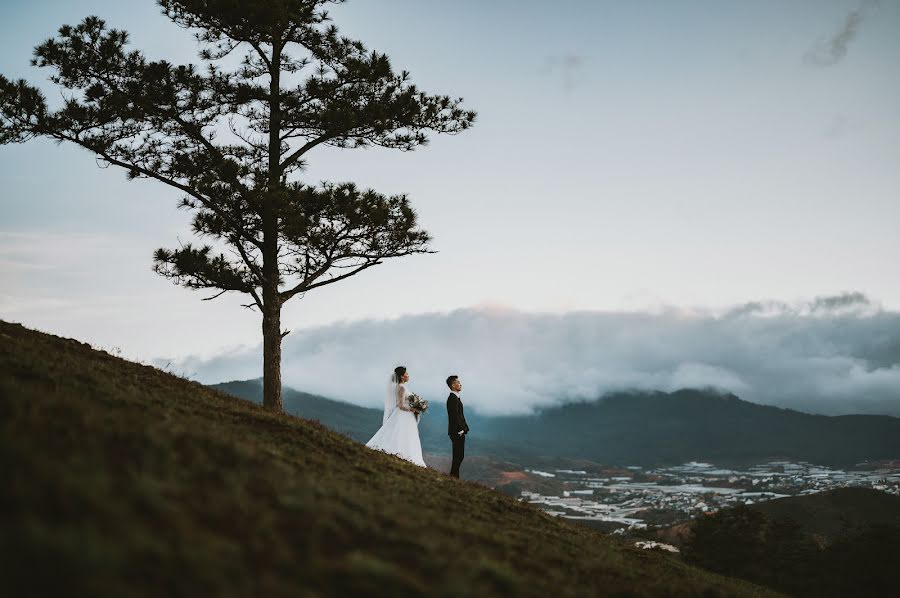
[487,390,900,466]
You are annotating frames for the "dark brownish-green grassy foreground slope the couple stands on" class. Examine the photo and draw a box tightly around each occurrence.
[0,322,766,597]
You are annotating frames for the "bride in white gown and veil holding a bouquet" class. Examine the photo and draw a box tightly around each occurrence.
[366,366,425,467]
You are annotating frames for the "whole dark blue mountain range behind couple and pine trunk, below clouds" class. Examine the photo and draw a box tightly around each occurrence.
[214,380,900,466]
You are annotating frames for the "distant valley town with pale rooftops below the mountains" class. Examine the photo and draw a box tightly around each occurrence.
[520,461,900,531]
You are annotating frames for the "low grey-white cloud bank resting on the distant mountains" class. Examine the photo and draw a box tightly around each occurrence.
[175,293,900,416]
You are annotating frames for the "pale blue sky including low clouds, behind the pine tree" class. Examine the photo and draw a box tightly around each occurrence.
[0,0,900,413]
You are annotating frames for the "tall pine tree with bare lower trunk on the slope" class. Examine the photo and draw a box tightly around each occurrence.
[0,0,475,411]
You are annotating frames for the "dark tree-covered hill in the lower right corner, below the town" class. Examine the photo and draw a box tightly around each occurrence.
[683,488,900,598]
